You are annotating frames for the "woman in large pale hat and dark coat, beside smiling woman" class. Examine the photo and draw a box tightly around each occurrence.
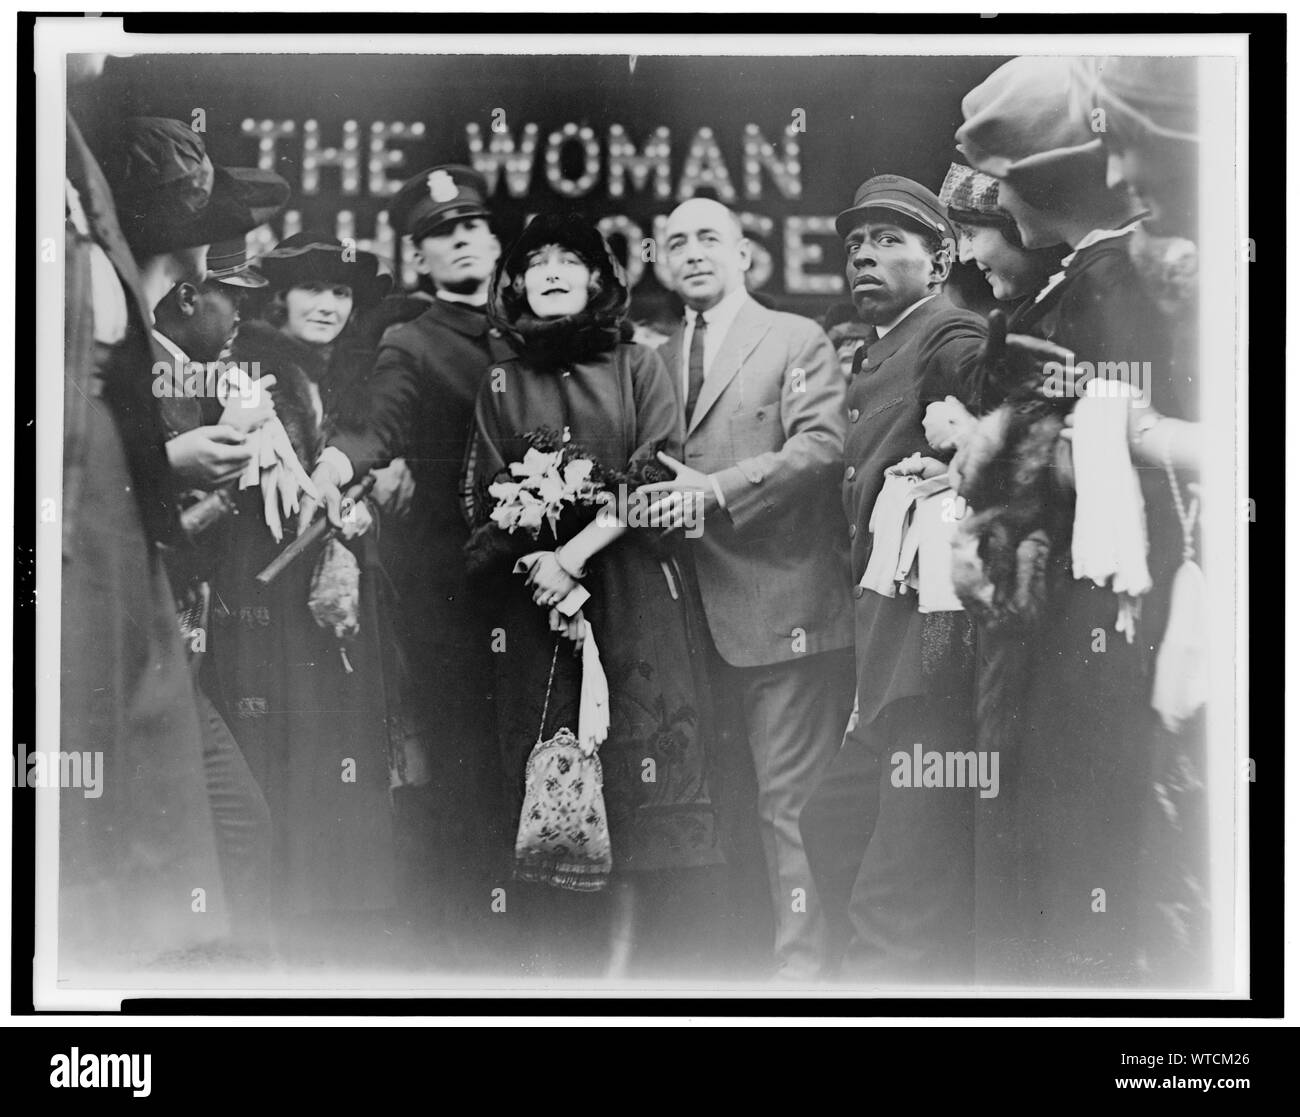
[957,59,1180,987]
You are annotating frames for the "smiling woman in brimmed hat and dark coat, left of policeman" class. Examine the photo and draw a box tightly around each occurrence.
[212,233,395,941]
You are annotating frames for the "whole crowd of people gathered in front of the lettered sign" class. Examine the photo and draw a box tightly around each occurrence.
[60,57,1210,988]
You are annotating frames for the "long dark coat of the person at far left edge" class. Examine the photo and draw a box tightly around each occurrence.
[62,113,228,966]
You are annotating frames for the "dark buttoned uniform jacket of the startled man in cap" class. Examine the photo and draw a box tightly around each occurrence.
[844,294,985,724]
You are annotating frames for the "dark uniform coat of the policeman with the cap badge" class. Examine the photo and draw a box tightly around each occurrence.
[334,299,514,926]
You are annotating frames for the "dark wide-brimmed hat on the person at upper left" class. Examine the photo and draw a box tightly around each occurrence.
[104,117,290,256]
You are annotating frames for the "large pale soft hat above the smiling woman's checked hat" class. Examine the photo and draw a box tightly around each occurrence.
[957,57,1105,182]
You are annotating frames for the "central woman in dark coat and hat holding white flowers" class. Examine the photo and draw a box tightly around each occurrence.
[467,217,722,974]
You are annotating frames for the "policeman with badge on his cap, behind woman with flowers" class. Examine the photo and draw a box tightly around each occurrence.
[304,165,501,957]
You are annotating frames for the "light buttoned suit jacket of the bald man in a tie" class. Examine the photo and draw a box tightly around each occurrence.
[660,292,853,667]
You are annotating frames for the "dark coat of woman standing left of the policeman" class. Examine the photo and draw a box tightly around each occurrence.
[208,321,397,915]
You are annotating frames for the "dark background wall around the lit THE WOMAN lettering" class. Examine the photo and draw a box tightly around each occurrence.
[70,55,1005,319]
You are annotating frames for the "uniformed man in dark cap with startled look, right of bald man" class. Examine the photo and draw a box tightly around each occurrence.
[801,174,984,980]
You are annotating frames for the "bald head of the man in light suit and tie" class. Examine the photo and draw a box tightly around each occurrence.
[664,198,753,311]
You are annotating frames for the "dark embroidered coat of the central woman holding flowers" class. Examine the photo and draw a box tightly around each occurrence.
[469,327,722,870]
